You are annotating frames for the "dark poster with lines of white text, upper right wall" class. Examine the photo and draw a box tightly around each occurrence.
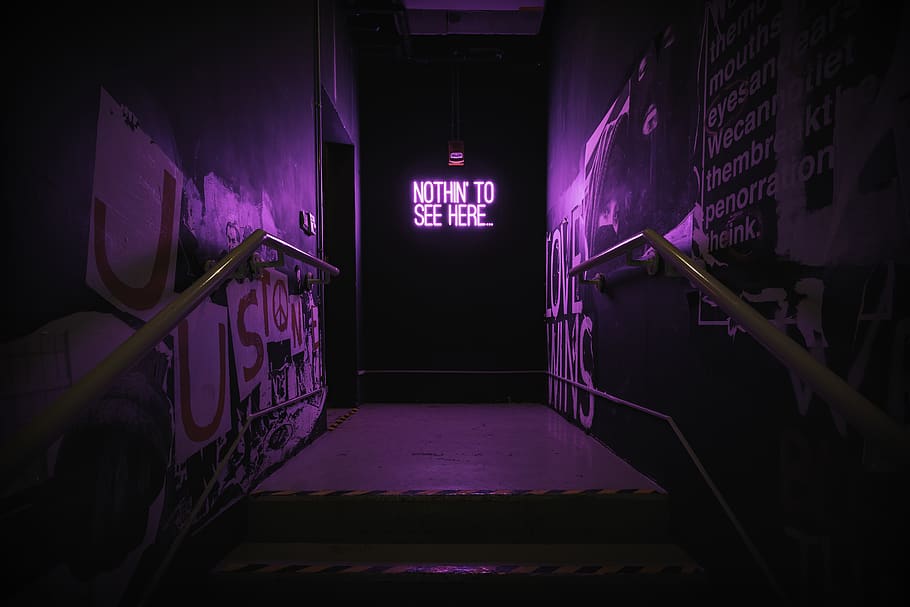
[693,2,910,286]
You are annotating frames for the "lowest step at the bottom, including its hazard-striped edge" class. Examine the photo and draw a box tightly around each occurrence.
[183,542,708,603]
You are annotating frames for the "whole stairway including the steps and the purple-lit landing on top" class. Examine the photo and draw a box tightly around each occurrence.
[148,406,708,605]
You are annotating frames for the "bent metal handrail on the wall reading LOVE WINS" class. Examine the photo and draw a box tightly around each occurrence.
[569,229,910,465]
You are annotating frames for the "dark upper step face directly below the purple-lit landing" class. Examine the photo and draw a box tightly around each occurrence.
[246,489,669,544]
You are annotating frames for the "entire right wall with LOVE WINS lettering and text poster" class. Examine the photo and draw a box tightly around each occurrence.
[545,0,910,598]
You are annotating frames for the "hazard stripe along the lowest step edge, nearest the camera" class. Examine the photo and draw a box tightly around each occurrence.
[216,562,702,576]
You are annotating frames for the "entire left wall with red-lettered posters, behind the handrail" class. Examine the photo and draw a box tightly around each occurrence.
[0,2,357,604]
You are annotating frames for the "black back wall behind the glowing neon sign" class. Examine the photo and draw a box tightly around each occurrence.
[360,43,546,401]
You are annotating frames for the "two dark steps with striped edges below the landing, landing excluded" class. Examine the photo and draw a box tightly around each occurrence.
[151,490,706,605]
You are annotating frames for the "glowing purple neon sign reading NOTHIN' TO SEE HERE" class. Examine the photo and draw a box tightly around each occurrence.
[411,179,496,228]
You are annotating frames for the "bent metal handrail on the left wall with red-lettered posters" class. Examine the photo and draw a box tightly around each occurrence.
[0,229,340,487]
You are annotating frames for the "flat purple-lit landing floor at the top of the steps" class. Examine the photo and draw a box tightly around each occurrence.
[255,403,664,493]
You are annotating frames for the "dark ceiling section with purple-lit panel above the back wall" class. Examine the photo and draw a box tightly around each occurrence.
[347,0,545,65]
